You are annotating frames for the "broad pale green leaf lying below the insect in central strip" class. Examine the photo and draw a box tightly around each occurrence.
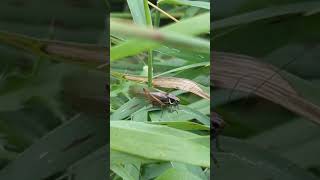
[110,121,210,167]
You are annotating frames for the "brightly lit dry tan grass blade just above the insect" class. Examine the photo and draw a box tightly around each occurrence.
[122,75,210,100]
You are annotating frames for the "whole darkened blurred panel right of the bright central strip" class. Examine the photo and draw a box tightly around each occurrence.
[211,0,320,180]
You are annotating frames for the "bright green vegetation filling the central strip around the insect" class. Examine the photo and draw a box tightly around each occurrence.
[110,0,210,180]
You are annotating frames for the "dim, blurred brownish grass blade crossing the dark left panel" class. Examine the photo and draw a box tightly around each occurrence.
[0,31,109,66]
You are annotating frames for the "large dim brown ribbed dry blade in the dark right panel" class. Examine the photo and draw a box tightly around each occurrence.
[211,52,320,124]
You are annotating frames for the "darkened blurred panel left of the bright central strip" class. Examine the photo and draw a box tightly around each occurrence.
[0,0,109,180]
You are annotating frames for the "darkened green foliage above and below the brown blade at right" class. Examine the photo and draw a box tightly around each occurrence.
[211,0,320,180]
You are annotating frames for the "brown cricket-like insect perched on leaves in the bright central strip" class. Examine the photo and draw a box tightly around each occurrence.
[143,88,180,112]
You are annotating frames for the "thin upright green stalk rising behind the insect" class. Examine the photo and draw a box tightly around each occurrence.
[143,0,153,87]
